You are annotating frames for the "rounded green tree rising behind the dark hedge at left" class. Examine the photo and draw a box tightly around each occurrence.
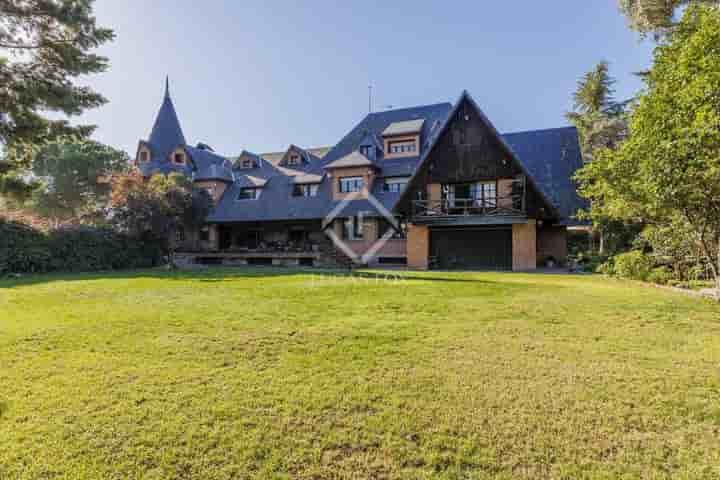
[30,140,130,224]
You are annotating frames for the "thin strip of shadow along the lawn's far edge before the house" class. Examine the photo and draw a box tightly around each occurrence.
[0,267,532,289]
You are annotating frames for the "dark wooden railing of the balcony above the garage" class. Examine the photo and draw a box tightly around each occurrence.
[412,195,526,218]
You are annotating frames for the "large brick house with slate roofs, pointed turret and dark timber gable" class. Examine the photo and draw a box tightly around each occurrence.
[136,82,583,270]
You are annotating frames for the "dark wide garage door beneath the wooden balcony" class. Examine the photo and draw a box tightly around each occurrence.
[430,227,512,270]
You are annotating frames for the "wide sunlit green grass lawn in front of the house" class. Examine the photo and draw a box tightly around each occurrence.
[0,270,720,479]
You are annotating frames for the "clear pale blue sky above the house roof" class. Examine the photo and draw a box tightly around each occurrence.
[80,0,653,155]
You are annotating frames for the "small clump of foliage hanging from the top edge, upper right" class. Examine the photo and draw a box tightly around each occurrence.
[619,0,720,38]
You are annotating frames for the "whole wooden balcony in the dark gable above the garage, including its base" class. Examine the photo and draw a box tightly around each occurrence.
[412,195,527,225]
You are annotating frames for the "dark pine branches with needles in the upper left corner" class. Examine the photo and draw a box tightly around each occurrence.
[0,0,114,184]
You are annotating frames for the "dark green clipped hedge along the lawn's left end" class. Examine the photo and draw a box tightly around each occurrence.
[0,218,163,275]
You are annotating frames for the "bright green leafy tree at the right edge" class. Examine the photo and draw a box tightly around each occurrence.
[578,5,720,289]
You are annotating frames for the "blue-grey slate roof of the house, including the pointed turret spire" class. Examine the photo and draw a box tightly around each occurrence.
[139,84,585,224]
